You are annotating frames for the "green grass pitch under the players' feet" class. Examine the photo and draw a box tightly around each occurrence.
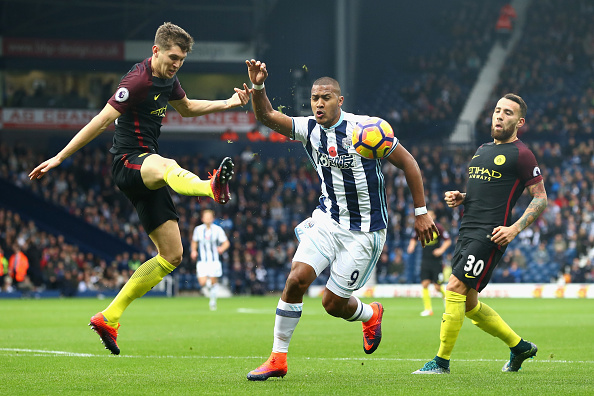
[0,297,594,395]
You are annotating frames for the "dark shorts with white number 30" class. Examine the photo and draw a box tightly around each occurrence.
[452,236,505,293]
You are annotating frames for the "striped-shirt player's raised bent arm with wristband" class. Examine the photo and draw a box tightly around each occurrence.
[245,59,293,137]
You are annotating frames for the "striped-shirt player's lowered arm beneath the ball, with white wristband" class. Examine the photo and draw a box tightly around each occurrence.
[388,144,439,247]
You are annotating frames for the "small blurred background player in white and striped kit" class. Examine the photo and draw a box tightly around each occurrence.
[190,209,231,311]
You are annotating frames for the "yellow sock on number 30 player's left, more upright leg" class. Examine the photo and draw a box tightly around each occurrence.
[437,290,466,360]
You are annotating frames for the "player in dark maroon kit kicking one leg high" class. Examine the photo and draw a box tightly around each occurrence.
[29,22,249,355]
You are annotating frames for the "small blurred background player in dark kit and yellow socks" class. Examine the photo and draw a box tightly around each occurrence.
[406,210,452,316]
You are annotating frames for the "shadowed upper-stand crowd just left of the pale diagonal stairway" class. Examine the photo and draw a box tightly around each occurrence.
[363,0,505,140]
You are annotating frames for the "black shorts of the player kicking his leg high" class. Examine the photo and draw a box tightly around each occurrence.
[111,153,179,234]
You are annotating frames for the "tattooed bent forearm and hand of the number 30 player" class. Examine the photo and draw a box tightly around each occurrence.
[491,181,548,246]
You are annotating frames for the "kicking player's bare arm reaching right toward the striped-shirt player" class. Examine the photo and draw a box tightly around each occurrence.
[169,84,250,117]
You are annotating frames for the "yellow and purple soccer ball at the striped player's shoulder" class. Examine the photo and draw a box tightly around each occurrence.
[353,117,394,159]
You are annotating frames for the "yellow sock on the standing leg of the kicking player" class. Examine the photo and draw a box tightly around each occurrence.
[103,255,175,326]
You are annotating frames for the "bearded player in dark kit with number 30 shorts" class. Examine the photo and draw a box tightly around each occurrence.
[413,94,547,374]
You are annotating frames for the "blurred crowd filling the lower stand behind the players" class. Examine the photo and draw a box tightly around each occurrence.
[0,133,594,295]
